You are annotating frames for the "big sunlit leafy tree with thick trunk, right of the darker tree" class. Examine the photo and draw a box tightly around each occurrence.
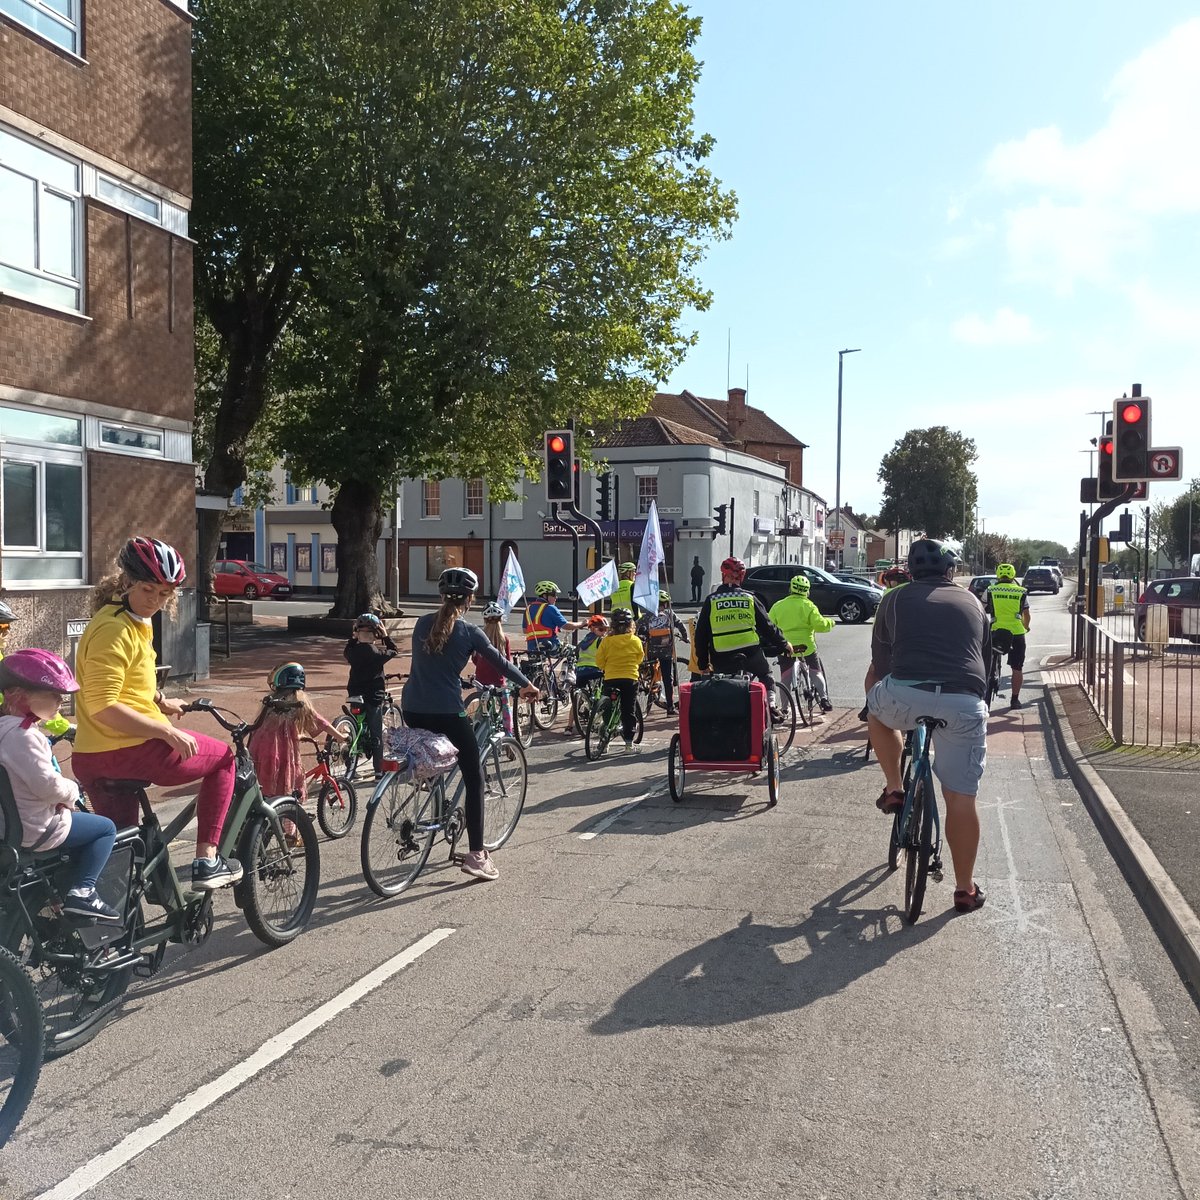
[278,0,734,614]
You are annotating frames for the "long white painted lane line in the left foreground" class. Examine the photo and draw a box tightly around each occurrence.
[35,929,455,1200]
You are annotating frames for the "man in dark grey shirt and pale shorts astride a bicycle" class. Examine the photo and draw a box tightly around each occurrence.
[866,538,991,912]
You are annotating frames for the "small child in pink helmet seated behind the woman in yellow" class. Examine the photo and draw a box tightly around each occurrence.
[0,650,121,920]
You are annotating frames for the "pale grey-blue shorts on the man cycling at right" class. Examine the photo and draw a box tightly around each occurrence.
[866,676,988,796]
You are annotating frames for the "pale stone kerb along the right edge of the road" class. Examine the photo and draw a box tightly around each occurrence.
[1046,686,1200,1000]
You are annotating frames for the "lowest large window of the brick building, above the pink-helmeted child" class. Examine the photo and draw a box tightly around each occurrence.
[0,408,84,583]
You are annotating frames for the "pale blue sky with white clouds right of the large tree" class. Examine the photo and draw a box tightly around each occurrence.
[665,0,1200,545]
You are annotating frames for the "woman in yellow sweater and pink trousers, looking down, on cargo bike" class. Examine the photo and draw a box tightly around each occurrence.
[71,538,241,890]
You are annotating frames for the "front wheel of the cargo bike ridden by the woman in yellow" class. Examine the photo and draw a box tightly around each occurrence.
[238,799,320,946]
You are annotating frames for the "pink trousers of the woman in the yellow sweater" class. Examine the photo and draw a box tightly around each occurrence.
[71,730,234,845]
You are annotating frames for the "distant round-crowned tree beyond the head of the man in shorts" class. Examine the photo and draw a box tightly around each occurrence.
[878,425,978,540]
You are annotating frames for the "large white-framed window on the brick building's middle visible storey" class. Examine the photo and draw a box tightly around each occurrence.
[0,126,83,312]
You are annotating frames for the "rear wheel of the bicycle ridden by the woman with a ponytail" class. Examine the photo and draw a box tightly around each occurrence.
[361,773,436,896]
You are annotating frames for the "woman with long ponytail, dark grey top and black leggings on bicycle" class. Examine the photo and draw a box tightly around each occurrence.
[401,566,538,880]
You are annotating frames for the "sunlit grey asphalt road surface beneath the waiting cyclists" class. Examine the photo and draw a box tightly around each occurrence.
[9,578,1200,1200]
